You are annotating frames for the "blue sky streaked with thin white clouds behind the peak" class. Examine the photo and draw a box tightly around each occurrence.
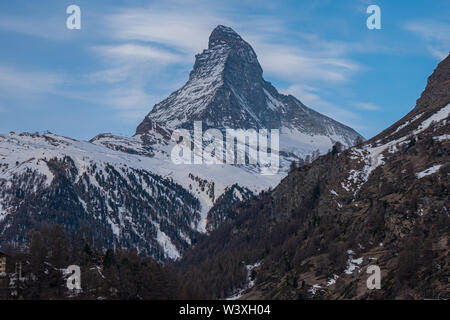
[0,0,450,139]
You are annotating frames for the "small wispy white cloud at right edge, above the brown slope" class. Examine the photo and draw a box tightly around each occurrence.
[404,21,450,60]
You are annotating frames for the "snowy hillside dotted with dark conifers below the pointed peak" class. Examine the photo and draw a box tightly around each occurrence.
[0,134,280,260]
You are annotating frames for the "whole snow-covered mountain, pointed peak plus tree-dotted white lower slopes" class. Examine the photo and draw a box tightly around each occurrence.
[0,26,360,261]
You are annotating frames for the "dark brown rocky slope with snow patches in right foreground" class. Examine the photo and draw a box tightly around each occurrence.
[177,57,450,299]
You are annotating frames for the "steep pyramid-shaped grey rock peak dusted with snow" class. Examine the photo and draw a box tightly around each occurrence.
[136,26,360,158]
